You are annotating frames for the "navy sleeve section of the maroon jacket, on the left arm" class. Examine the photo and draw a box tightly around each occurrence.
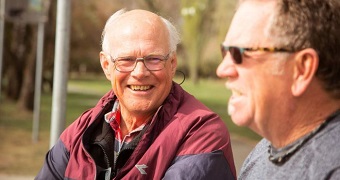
[35,139,70,180]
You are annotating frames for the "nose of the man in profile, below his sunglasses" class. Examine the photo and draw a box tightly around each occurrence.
[216,53,238,78]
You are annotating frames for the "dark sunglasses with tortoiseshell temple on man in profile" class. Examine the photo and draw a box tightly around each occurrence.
[221,44,293,64]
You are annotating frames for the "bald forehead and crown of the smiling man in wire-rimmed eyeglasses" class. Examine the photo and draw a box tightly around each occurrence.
[107,11,169,52]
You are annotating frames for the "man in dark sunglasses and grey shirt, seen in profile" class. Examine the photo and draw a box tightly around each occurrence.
[216,0,340,180]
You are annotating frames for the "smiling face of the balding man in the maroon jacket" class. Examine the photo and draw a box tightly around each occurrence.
[100,10,177,121]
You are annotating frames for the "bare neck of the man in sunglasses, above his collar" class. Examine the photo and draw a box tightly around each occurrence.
[266,94,340,148]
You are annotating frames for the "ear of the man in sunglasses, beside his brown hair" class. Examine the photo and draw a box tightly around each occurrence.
[291,48,319,97]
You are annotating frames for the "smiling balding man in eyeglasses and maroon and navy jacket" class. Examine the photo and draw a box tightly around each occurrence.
[36,10,236,180]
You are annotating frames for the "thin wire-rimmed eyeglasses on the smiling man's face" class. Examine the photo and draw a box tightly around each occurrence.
[110,53,171,72]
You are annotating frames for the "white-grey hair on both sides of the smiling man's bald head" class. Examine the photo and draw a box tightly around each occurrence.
[101,9,181,52]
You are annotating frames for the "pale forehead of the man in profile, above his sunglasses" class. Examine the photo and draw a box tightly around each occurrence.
[224,0,276,47]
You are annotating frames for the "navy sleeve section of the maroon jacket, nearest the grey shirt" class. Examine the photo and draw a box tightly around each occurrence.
[163,150,236,180]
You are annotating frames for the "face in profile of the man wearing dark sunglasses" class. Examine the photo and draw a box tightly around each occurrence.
[216,1,292,136]
